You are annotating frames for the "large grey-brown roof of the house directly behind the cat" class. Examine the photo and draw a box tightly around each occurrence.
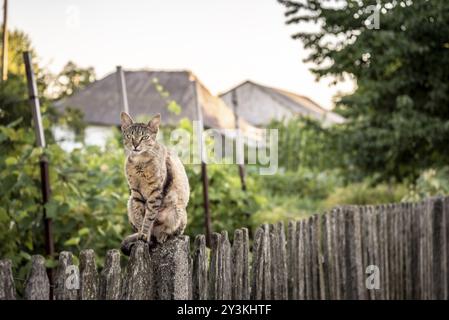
[55,70,257,142]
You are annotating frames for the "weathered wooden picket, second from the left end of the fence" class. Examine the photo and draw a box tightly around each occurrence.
[24,255,50,300]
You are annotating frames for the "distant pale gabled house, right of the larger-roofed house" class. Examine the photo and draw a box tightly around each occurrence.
[220,81,344,126]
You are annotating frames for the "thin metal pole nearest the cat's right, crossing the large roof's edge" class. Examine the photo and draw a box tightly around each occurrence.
[191,75,212,247]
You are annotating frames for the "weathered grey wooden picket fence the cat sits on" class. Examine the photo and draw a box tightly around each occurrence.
[0,198,449,300]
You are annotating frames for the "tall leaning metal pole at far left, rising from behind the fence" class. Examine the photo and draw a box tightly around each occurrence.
[23,52,55,297]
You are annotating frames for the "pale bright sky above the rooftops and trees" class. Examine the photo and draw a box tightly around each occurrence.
[8,0,352,109]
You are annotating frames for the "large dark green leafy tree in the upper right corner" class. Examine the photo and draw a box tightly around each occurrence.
[279,0,449,179]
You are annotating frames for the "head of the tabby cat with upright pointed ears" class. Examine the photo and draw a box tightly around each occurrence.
[120,112,161,155]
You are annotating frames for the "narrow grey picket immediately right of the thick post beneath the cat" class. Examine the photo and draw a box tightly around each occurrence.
[192,234,208,300]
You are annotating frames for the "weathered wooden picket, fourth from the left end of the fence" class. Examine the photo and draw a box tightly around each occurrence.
[79,249,99,300]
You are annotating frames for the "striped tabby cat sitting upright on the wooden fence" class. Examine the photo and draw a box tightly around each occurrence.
[120,112,190,255]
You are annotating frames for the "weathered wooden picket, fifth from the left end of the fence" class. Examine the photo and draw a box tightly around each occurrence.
[99,249,122,300]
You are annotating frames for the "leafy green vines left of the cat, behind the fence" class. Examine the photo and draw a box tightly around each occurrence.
[0,123,131,282]
